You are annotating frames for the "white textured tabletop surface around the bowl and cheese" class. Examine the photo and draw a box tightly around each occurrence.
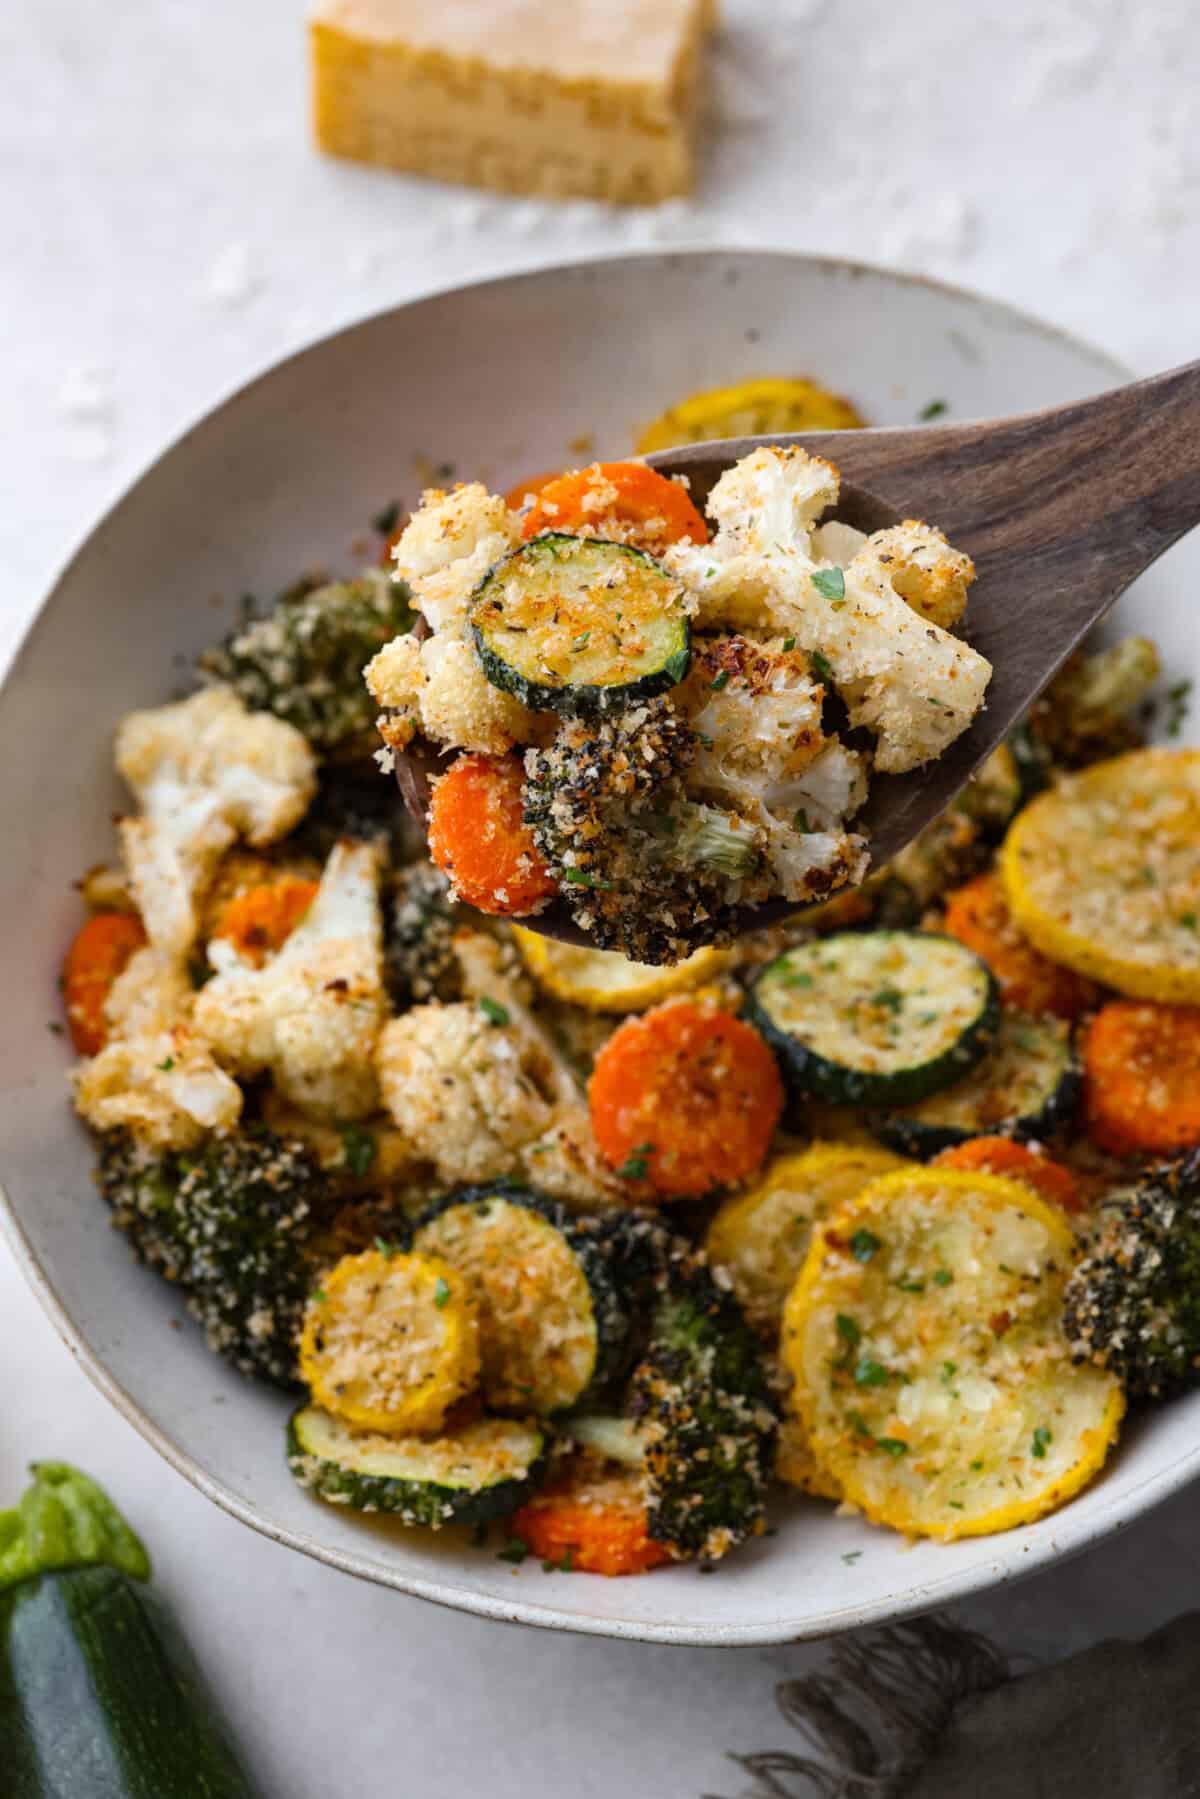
[0,0,1200,1799]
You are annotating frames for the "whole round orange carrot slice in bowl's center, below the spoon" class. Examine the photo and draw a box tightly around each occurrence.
[588,1000,783,1198]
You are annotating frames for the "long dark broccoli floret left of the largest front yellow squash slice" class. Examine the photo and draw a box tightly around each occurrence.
[572,1213,777,1562]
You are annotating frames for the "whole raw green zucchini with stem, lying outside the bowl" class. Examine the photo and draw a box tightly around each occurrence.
[0,1463,257,1799]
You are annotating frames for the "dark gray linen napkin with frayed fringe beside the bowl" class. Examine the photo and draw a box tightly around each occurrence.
[719,1612,1200,1799]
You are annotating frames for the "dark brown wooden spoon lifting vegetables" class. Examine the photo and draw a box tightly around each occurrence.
[396,349,1200,943]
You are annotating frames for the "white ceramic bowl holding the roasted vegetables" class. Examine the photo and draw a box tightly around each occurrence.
[0,252,1200,1644]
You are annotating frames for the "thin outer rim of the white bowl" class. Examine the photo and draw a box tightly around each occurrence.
[0,253,1165,1648]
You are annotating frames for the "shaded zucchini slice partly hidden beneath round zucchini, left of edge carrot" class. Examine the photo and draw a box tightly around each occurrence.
[873,1011,1083,1160]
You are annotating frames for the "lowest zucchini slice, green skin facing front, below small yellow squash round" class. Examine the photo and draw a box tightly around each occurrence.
[288,1405,545,1529]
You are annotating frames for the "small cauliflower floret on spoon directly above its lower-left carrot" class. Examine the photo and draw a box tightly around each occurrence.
[367,635,534,756]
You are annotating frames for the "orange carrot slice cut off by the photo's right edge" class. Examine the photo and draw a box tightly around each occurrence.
[1083,1000,1200,1155]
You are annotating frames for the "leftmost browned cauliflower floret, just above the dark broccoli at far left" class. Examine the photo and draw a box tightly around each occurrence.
[72,946,241,1150]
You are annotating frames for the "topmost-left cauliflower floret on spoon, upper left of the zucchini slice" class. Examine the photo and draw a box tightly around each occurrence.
[392,482,520,631]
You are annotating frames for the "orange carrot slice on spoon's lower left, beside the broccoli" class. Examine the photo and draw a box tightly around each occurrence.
[430,756,558,917]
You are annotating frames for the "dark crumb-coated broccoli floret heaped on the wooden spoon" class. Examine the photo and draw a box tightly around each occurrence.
[525,698,759,962]
